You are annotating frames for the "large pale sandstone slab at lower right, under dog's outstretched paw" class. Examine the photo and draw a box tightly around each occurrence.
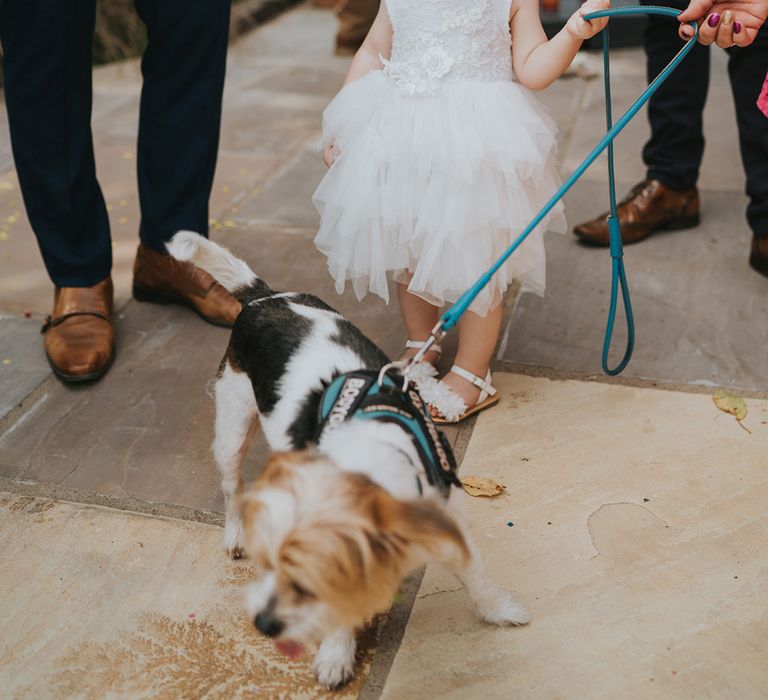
[382,373,768,700]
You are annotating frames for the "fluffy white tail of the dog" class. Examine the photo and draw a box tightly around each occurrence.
[165,231,272,304]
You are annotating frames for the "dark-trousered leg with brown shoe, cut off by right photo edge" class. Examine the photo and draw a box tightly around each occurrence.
[728,22,768,277]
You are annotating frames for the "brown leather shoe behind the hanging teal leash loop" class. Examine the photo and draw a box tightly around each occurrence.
[573,180,700,246]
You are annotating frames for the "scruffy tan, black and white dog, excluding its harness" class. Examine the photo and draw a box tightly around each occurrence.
[168,232,528,687]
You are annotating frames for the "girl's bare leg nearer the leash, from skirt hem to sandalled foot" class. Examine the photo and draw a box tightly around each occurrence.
[432,304,503,415]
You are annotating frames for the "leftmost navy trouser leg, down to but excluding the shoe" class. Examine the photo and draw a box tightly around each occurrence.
[0,0,112,287]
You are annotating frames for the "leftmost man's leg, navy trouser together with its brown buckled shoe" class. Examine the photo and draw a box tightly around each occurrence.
[0,0,114,382]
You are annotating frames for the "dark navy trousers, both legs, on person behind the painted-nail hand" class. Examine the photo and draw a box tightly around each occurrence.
[643,0,768,236]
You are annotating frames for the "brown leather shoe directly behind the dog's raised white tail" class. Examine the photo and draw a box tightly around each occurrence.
[133,243,242,328]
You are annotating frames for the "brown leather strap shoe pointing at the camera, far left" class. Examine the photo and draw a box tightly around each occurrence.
[41,277,115,383]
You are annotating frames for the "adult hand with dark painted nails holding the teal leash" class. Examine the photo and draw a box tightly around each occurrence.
[678,0,768,49]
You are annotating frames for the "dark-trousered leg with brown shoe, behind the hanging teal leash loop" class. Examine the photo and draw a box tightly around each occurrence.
[573,0,709,246]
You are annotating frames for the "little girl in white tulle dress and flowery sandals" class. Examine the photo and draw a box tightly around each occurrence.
[314,0,609,422]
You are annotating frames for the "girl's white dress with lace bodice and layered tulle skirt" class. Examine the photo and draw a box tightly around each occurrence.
[313,0,565,315]
